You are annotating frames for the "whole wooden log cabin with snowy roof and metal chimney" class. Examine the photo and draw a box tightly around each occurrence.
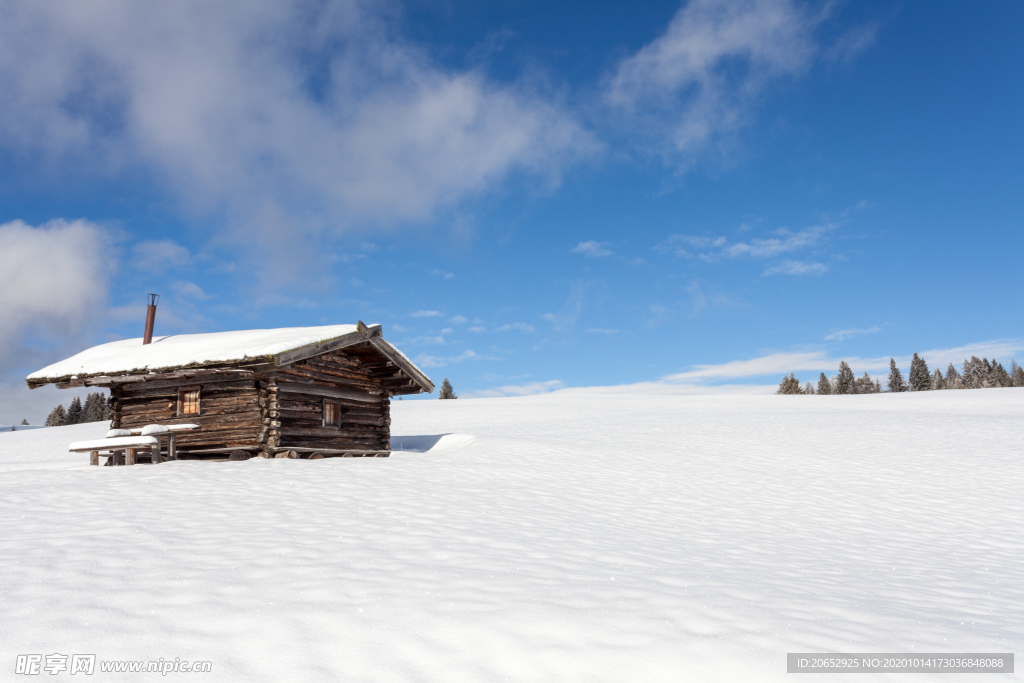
[27,321,434,459]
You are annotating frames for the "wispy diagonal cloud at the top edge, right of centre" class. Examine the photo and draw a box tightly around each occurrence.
[606,0,819,155]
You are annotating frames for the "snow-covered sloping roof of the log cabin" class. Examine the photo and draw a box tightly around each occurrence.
[26,325,425,393]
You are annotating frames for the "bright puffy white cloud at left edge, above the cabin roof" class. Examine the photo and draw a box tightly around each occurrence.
[0,220,114,343]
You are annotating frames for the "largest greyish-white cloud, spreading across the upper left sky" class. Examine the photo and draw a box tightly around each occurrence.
[0,0,598,244]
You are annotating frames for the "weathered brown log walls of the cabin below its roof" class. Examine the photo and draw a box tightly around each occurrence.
[111,344,403,459]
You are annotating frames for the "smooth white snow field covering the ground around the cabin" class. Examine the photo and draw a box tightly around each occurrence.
[0,389,1024,683]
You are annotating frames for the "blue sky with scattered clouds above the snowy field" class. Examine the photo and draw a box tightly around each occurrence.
[0,0,1024,423]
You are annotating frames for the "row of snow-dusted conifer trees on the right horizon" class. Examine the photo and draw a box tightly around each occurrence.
[775,353,1024,394]
